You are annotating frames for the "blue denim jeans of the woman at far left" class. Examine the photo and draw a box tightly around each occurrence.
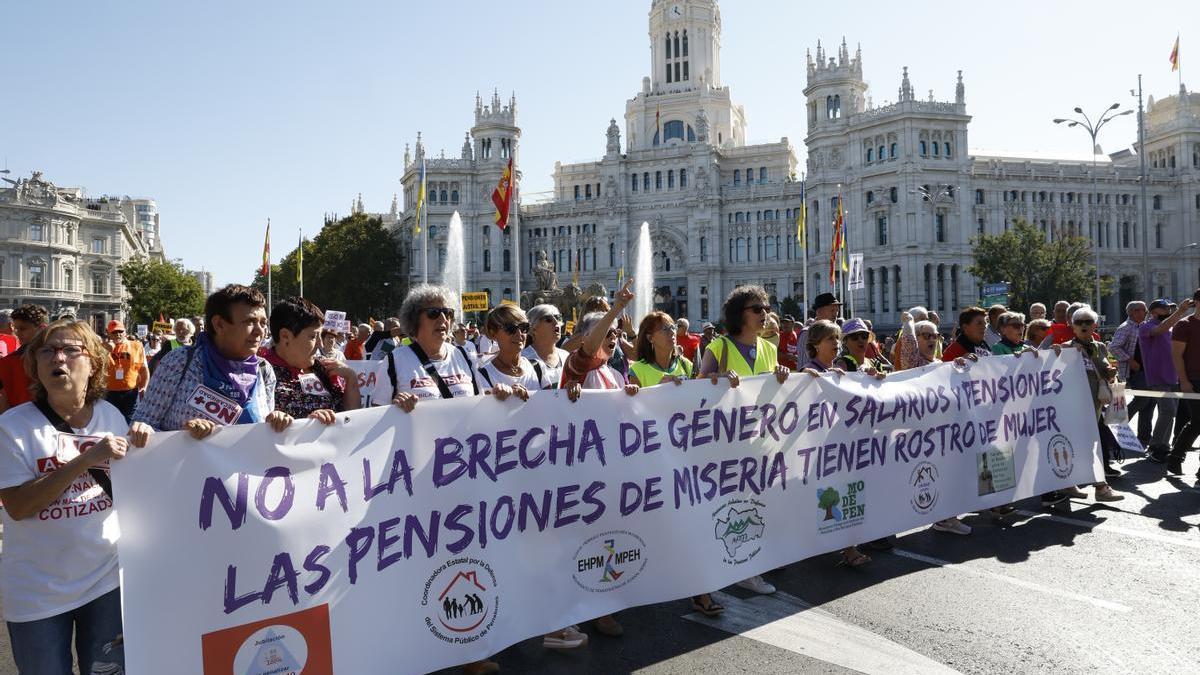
[8,589,125,675]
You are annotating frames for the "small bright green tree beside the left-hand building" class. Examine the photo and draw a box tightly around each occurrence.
[116,256,204,323]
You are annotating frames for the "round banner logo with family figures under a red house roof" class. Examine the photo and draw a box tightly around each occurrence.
[421,557,500,645]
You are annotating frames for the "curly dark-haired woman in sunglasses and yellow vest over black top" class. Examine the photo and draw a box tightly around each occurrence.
[700,286,792,595]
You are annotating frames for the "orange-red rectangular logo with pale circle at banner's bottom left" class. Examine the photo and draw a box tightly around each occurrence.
[200,604,334,675]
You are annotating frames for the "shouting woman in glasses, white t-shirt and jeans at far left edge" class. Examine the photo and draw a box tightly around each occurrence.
[0,319,151,673]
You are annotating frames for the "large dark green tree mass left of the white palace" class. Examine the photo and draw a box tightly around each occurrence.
[252,214,406,322]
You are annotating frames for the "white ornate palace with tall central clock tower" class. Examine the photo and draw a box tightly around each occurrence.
[398,0,1200,325]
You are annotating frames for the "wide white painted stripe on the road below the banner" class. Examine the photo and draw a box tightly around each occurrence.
[684,592,958,675]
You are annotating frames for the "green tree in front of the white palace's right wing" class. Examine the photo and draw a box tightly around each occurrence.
[967,220,1112,307]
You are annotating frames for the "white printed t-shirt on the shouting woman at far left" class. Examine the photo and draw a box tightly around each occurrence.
[0,400,130,622]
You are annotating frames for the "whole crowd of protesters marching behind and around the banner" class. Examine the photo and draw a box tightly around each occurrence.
[0,280,1200,674]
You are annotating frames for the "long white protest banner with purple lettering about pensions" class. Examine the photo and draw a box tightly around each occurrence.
[113,350,1102,675]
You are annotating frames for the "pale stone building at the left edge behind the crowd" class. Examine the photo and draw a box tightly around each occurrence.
[0,172,163,329]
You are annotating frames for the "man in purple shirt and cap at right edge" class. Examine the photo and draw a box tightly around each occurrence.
[1138,298,1195,464]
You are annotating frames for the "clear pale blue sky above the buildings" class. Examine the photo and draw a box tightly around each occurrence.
[0,0,1200,283]
